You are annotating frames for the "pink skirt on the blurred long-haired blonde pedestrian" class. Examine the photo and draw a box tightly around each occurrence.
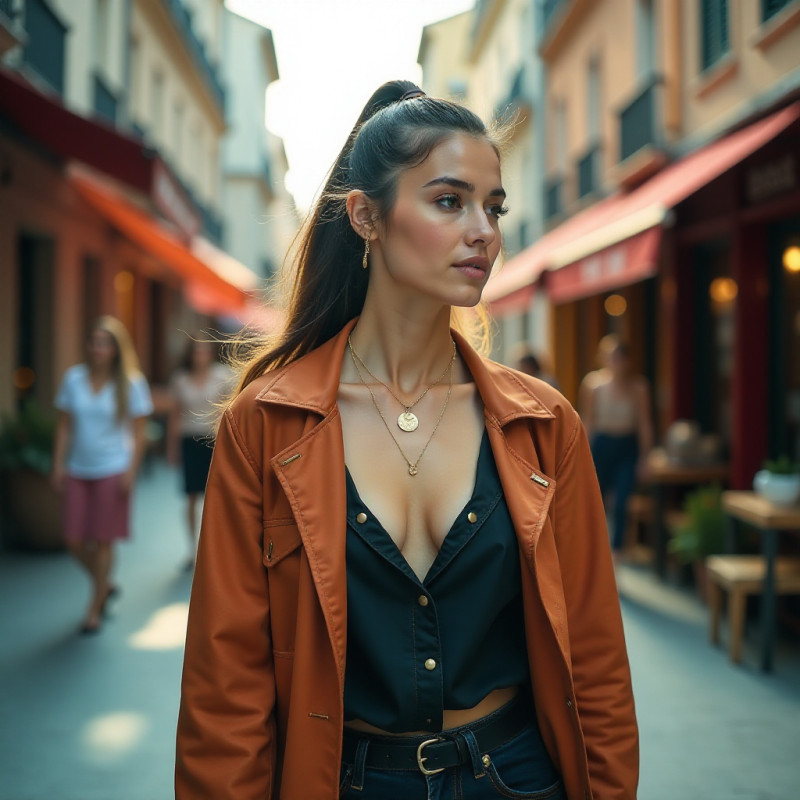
[64,474,131,544]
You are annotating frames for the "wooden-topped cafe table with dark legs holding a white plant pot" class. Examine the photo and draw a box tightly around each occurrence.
[722,492,800,672]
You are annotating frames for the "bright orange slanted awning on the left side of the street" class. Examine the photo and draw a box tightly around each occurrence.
[70,172,248,314]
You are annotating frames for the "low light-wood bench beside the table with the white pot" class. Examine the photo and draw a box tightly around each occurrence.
[706,555,800,664]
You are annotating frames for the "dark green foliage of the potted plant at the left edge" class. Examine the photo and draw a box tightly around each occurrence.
[0,400,56,475]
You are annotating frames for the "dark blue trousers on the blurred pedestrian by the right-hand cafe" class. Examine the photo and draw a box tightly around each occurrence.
[592,433,639,550]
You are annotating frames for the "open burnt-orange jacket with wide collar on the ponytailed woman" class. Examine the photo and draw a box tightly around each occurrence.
[176,323,638,800]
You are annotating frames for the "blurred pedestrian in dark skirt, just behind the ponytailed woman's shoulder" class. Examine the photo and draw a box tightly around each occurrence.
[167,336,234,570]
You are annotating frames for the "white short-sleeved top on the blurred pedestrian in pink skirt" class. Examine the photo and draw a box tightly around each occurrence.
[55,364,153,478]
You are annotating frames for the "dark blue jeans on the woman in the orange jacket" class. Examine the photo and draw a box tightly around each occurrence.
[339,712,567,800]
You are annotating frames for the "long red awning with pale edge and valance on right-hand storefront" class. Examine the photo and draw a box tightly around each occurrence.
[486,103,800,309]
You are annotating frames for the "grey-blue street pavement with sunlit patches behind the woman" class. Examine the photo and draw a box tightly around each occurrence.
[0,465,800,800]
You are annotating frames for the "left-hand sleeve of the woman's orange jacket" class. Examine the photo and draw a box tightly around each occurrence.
[175,410,275,800]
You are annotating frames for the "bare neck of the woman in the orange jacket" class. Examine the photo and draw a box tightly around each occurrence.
[348,302,453,394]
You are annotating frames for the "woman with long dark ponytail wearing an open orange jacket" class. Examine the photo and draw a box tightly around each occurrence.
[176,81,637,800]
